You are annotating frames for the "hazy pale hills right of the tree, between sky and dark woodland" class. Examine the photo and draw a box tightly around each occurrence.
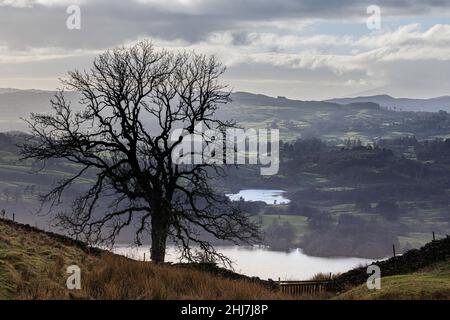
[225,92,450,144]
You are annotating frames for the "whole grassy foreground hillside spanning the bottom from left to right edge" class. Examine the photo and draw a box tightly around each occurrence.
[0,219,450,299]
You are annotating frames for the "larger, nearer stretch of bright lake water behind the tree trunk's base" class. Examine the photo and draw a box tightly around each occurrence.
[114,245,373,280]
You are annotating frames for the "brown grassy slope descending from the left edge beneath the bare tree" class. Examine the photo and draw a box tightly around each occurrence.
[0,220,286,299]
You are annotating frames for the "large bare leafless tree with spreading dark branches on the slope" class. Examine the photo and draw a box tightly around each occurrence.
[22,41,258,263]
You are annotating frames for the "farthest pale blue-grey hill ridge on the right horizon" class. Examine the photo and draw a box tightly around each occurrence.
[326,95,450,112]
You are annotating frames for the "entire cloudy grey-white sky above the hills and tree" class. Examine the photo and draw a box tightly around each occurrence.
[0,0,450,100]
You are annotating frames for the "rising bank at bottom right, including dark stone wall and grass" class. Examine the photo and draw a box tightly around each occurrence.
[331,236,450,299]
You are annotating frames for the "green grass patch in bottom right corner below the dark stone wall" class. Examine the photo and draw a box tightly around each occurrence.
[336,259,450,300]
